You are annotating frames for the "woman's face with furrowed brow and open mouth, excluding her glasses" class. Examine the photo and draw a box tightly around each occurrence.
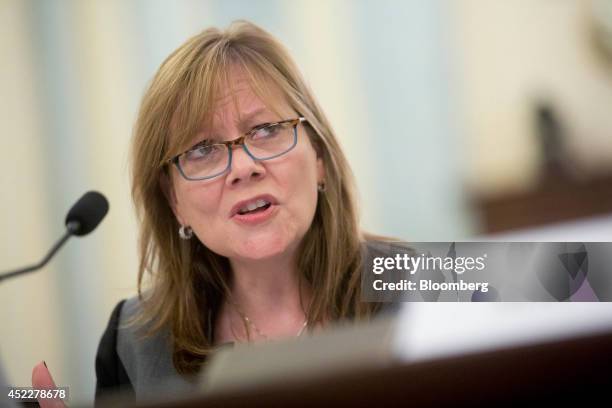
[165,73,324,261]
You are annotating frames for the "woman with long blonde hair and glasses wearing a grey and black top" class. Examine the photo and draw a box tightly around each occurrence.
[32,21,392,404]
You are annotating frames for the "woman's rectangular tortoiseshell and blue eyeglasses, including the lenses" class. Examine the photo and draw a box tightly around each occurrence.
[168,117,306,180]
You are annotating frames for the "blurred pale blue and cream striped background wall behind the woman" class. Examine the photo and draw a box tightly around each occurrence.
[0,0,612,401]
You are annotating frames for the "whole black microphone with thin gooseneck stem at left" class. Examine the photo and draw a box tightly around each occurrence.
[0,191,108,282]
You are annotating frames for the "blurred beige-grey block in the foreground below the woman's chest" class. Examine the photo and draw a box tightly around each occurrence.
[202,318,397,392]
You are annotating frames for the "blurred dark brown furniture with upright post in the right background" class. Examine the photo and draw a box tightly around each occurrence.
[474,102,612,233]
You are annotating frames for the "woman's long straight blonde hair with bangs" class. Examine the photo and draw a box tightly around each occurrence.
[132,21,377,374]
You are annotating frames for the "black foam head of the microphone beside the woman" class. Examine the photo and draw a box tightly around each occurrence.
[66,191,108,236]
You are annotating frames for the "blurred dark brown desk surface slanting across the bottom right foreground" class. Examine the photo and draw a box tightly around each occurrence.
[123,333,612,408]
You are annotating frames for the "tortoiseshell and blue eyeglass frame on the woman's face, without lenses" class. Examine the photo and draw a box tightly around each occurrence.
[167,116,306,181]
